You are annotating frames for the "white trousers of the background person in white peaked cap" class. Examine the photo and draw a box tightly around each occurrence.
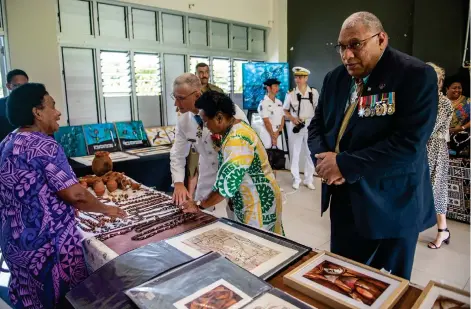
[287,121,314,185]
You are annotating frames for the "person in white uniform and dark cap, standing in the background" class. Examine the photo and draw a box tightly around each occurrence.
[258,78,285,149]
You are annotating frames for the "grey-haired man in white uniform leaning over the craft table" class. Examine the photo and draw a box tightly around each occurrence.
[170,73,248,216]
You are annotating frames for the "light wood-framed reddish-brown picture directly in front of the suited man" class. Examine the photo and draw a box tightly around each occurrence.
[283,251,409,309]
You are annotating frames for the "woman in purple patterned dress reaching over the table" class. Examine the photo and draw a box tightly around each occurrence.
[0,83,126,308]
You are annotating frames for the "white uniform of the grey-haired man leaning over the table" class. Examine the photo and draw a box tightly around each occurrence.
[170,104,248,201]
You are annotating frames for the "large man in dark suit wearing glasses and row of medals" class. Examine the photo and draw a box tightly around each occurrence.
[309,12,438,279]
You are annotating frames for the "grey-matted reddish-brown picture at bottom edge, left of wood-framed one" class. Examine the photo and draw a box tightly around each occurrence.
[126,252,271,309]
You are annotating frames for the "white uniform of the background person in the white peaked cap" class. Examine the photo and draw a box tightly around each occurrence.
[283,86,319,185]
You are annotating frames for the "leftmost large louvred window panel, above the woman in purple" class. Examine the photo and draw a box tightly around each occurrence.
[62,47,98,126]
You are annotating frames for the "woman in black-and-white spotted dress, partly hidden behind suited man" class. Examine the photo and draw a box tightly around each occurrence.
[427,62,453,249]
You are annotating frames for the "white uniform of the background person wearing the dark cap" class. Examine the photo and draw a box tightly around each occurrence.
[257,95,285,149]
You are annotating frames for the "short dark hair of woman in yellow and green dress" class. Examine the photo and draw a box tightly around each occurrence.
[195,91,235,119]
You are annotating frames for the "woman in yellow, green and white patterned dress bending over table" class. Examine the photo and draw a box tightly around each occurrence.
[182,91,284,235]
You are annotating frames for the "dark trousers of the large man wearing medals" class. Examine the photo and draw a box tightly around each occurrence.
[330,196,419,280]
